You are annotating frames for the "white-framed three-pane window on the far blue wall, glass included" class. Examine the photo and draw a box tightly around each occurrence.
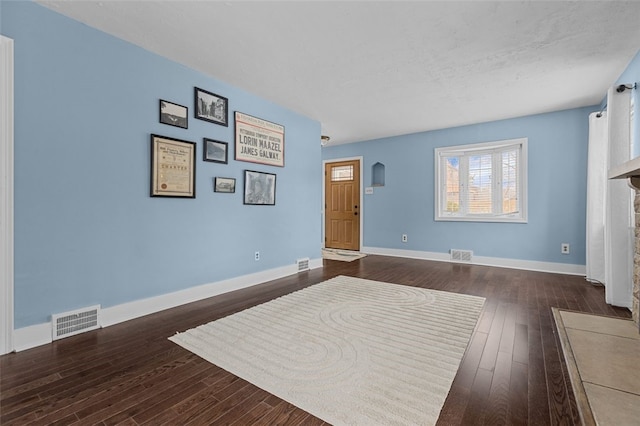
[435,138,527,222]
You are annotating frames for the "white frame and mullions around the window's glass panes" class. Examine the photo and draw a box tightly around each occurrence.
[434,138,528,223]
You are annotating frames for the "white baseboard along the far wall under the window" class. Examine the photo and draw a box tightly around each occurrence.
[360,247,587,276]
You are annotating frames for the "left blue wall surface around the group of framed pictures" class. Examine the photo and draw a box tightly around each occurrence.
[0,2,321,328]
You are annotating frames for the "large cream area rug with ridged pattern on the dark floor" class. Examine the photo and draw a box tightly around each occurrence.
[170,276,484,426]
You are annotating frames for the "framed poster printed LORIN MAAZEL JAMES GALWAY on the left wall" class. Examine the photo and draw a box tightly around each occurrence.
[235,111,284,167]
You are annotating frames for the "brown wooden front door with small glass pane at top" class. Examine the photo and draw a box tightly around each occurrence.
[324,160,361,250]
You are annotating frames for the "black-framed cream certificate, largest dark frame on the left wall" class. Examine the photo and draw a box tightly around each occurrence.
[151,135,196,198]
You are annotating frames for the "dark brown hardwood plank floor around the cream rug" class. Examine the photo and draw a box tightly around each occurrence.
[0,256,630,425]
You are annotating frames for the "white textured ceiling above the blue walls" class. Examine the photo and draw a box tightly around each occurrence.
[38,0,640,144]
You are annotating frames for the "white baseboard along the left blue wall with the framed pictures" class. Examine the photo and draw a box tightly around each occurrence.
[13,258,322,352]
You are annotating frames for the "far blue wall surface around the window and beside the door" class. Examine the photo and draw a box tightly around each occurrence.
[322,106,598,265]
